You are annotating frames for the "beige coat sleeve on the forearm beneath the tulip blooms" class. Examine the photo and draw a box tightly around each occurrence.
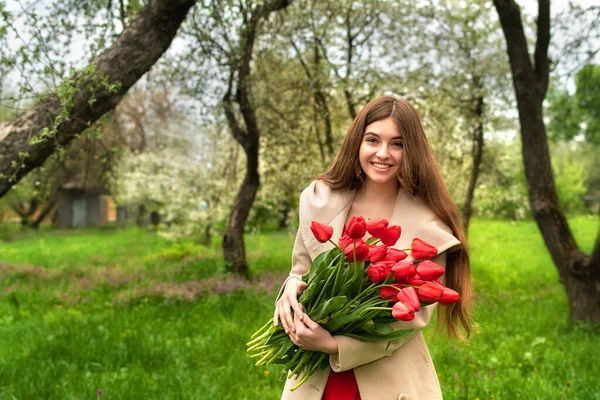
[329,252,446,372]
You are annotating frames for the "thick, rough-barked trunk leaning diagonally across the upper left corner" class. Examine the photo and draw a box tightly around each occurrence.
[0,0,195,197]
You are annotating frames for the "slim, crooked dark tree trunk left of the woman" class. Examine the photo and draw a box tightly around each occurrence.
[223,0,291,278]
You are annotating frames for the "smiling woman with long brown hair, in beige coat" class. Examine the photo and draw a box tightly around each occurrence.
[274,96,471,400]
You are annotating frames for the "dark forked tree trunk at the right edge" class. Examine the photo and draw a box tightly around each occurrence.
[494,0,600,322]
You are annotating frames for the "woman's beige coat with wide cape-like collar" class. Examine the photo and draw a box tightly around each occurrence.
[277,180,460,400]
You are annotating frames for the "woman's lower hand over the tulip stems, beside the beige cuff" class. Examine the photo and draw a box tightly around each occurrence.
[289,314,338,354]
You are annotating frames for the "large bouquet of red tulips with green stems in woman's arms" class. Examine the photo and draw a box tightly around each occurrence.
[247,217,459,390]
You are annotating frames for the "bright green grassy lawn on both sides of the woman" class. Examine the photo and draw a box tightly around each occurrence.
[0,217,600,399]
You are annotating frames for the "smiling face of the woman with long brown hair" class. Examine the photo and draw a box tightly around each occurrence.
[358,117,404,184]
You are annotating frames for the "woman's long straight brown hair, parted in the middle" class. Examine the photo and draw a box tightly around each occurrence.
[317,96,472,339]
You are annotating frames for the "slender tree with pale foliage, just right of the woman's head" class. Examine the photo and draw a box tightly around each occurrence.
[391,0,513,230]
